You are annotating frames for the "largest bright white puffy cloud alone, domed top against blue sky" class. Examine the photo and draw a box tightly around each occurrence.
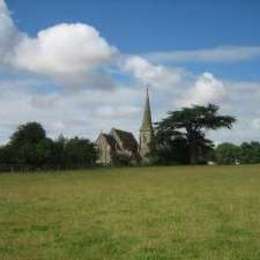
[14,23,115,76]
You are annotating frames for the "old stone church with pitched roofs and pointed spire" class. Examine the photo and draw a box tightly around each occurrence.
[96,89,154,165]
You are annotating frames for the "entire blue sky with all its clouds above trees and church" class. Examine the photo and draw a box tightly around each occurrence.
[0,0,260,143]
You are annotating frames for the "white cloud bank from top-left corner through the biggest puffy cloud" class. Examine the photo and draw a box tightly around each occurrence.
[0,0,117,87]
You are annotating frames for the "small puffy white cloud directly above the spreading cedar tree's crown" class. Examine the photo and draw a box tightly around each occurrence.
[179,72,227,106]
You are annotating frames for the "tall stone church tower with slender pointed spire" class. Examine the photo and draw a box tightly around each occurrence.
[139,88,154,162]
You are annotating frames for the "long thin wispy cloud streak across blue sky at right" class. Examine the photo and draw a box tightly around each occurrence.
[145,46,260,63]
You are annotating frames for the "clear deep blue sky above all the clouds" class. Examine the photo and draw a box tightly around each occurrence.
[7,0,260,49]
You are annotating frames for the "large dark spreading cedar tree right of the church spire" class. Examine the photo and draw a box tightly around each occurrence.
[156,104,236,164]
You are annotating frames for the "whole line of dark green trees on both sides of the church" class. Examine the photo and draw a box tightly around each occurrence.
[0,104,260,171]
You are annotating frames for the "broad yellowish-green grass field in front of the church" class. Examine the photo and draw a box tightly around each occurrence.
[0,165,260,260]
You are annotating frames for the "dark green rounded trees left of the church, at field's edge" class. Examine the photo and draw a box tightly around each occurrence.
[0,122,97,171]
